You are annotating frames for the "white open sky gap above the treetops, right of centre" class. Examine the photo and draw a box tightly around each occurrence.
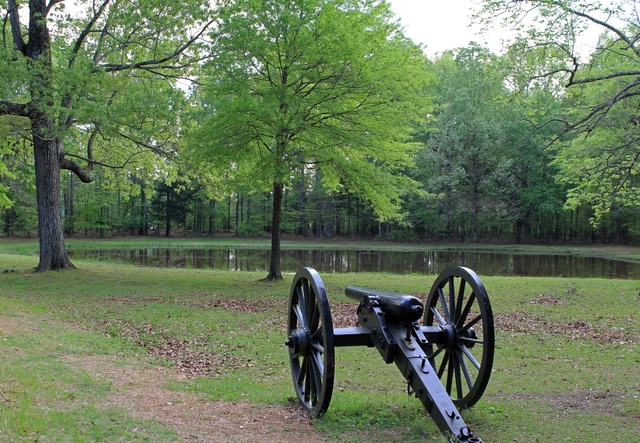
[388,0,508,56]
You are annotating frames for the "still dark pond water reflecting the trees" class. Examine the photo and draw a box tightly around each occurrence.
[69,248,640,279]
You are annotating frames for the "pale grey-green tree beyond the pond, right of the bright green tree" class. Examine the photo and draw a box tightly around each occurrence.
[420,45,513,242]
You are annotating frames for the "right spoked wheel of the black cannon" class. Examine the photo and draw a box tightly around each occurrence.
[424,266,495,409]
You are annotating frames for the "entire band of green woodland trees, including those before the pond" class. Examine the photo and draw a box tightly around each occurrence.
[0,0,640,270]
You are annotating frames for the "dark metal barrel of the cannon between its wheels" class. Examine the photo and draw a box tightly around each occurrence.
[344,285,424,323]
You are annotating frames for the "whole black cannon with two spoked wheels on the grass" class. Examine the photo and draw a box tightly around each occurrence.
[285,266,495,443]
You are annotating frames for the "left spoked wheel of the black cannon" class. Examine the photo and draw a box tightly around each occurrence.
[286,268,335,416]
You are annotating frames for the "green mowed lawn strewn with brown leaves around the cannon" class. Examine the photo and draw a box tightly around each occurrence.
[0,254,640,443]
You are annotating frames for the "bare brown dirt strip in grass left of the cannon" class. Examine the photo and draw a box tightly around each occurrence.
[69,356,326,443]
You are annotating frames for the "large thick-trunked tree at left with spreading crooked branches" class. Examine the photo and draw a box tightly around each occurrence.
[0,0,215,271]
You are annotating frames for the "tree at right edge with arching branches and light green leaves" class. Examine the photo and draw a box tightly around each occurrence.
[482,0,640,225]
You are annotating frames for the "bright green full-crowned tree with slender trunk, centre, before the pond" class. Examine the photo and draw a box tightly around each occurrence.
[189,0,427,280]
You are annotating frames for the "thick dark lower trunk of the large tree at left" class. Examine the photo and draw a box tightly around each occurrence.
[32,117,75,272]
